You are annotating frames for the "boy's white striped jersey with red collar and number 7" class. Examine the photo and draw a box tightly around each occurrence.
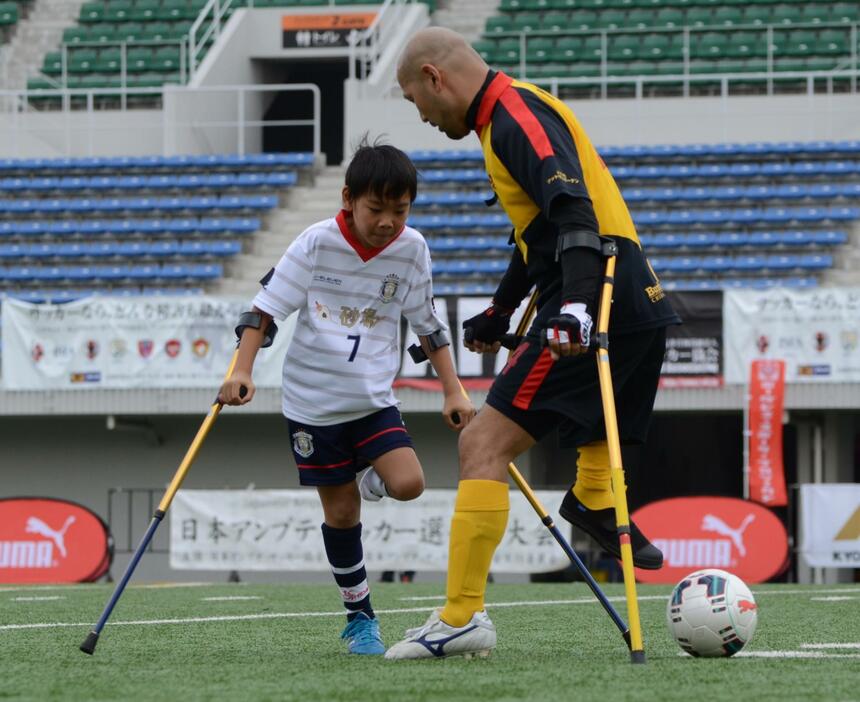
[254,212,446,425]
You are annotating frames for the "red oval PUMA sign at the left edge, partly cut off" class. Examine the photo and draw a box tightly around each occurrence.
[0,497,113,583]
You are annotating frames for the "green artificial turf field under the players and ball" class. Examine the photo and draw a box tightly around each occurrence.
[0,583,860,702]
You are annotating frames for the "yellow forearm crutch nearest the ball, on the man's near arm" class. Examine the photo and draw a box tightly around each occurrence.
[597,248,645,663]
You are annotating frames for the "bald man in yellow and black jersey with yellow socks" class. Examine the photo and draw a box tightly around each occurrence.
[386,27,679,659]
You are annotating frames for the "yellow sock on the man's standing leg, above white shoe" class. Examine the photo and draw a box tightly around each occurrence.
[442,480,510,626]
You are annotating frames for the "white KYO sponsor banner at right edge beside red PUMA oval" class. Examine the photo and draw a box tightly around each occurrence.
[800,483,860,568]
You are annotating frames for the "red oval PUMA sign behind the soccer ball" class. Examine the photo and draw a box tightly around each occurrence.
[632,497,788,583]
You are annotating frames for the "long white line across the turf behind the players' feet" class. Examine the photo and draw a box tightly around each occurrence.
[5,588,857,631]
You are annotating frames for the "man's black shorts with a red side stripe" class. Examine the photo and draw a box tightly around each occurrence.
[487,327,666,448]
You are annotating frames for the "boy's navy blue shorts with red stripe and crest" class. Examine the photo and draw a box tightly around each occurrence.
[287,407,412,485]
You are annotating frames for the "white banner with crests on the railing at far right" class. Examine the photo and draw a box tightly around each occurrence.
[723,288,860,384]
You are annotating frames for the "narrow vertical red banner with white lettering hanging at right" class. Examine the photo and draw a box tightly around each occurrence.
[749,359,788,507]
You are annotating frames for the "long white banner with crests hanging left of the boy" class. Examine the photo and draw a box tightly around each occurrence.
[2,296,294,390]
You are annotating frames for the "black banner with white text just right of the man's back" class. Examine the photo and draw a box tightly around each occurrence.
[660,291,723,388]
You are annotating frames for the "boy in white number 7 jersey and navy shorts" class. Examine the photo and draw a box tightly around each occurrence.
[219,140,475,654]
